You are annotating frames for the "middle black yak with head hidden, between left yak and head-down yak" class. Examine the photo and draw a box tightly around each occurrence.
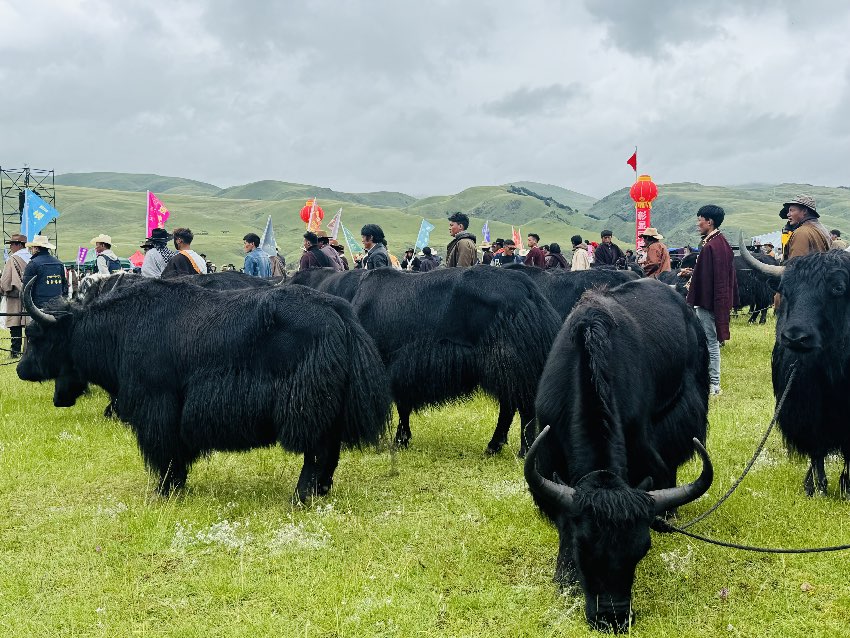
[344,266,561,454]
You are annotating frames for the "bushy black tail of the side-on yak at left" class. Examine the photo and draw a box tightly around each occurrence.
[341,312,392,446]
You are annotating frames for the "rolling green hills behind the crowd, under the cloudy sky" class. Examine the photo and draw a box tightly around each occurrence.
[44,173,850,263]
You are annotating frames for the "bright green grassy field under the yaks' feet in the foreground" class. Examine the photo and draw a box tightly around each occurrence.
[0,319,850,638]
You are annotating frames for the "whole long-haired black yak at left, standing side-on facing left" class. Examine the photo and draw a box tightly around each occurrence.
[17,275,390,501]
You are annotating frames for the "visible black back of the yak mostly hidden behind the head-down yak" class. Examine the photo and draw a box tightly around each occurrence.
[502,264,639,319]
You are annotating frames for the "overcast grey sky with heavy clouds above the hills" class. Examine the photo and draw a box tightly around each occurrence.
[0,0,850,196]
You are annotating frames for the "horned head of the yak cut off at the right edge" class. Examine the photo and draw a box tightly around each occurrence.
[741,235,850,359]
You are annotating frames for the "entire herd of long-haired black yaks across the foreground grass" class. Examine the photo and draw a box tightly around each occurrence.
[17,236,850,631]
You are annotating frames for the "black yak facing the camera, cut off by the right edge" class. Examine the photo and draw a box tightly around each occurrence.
[742,242,850,499]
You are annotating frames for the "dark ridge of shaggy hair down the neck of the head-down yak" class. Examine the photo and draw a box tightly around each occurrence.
[572,296,617,434]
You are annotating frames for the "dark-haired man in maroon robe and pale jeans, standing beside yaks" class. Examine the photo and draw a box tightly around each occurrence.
[679,204,745,396]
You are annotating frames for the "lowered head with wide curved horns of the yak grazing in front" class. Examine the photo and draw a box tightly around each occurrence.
[525,426,714,632]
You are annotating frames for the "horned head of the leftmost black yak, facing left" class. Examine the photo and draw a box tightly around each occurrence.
[17,279,87,408]
